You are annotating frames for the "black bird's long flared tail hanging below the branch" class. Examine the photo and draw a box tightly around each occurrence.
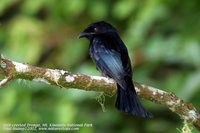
[115,84,153,118]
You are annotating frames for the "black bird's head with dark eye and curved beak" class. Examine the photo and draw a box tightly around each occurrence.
[78,21,116,39]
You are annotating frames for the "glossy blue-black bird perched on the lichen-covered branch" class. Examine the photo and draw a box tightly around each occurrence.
[79,21,152,117]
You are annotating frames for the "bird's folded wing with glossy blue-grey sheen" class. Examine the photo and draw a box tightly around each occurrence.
[92,42,126,84]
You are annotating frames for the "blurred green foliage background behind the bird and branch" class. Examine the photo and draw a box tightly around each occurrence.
[0,0,200,133]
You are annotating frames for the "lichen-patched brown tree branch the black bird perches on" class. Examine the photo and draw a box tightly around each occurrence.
[0,57,200,130]
